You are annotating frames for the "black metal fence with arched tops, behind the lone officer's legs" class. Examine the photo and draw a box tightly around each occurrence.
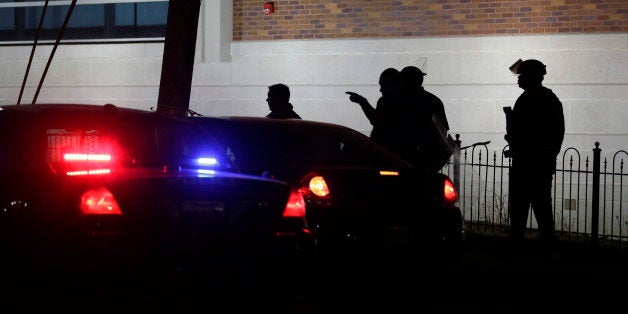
[441,135,628,245]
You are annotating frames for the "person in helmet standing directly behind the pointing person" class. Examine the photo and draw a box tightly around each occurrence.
[400,66,450,171]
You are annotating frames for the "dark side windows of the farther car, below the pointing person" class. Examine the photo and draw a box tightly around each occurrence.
[210,124,407,173]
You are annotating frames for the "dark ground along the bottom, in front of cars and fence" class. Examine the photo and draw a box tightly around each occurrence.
[4,234,628,313]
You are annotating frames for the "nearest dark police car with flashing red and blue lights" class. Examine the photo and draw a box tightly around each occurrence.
[0,104,315,270]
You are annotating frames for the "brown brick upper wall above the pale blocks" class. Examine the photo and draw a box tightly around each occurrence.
[233,0,628,41]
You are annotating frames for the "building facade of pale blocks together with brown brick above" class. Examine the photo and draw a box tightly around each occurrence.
[0,0,628,161]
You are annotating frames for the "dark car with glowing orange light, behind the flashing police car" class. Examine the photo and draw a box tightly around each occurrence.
[188,116,464,253]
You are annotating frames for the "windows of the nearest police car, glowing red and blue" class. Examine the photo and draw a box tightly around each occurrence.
[0,110,232,172]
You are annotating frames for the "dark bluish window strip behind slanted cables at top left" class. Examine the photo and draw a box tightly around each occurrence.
[0,0,168,45]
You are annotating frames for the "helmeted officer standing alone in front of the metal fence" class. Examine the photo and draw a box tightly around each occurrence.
[504,59,565,258]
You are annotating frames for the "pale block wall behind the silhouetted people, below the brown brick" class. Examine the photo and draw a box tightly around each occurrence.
[0,34,628,159]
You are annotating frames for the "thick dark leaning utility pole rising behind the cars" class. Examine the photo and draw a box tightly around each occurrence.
[157,0,201,116]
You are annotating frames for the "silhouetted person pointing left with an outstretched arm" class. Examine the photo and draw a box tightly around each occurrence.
[346,68,407,159]
